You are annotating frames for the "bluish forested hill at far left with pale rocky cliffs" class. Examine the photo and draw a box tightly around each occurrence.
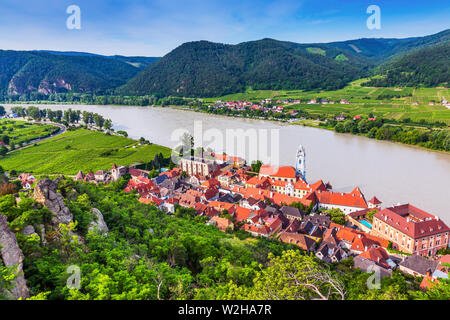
[0,50,158,95]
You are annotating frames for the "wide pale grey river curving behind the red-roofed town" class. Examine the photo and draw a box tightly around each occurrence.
[5,105,450,225]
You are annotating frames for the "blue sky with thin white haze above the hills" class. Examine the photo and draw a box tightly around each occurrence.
[0,0,450,56]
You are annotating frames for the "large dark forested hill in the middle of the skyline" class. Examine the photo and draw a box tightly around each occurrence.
[119,39,368,97]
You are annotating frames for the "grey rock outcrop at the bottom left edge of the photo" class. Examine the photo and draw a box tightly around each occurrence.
[0,214,30,299]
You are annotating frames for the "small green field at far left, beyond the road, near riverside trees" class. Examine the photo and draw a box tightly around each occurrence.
[0,119,60,145]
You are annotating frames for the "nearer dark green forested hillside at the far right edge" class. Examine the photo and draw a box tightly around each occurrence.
[365,41,450,87]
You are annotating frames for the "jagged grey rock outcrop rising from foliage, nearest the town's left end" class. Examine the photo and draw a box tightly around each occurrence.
[34,179,73,226]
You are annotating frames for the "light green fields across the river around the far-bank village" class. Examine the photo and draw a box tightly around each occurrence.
[203,79,450,125]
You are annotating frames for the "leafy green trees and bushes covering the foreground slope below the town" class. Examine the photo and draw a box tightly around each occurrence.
[0,178,448,300]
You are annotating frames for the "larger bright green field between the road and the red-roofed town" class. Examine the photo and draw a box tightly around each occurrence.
[0,129,171,175]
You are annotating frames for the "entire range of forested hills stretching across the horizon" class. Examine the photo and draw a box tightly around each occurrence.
[0,30,450,97]
